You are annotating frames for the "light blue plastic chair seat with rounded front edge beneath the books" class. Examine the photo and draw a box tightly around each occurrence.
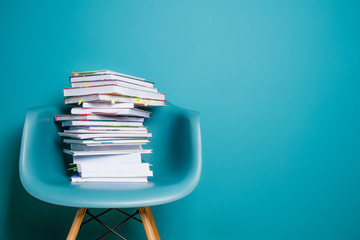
[23,178,200,208]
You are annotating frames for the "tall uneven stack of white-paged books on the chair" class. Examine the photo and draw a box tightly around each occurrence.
[55,70,165,182]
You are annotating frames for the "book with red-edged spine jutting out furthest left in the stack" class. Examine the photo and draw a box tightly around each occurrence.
[55,114,144,122]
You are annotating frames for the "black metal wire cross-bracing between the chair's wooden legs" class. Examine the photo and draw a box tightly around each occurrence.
[81,208,142,240]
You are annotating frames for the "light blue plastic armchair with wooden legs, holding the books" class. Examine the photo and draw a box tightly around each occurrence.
[19,102,201,239]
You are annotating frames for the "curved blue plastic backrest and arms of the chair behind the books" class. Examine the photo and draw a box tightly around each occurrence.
[19,103,201,205]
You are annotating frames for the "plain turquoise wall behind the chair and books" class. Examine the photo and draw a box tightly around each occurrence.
[0,0,360,239]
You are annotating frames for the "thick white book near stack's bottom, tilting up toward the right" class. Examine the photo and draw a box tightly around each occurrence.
[73,153,141,165]
